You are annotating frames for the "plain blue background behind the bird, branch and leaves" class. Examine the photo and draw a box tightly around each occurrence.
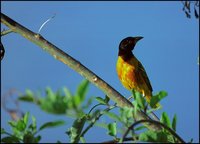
[1,2,199,142]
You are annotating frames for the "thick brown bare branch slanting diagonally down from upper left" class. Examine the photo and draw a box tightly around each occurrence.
[1,13,161,130]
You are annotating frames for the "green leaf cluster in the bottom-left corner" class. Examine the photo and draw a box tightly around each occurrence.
[1,112,65,143]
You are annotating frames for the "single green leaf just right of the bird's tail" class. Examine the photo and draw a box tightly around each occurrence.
[150,91,167,107]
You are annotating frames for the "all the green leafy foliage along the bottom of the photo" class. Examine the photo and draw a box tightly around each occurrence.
[1,80,188,143]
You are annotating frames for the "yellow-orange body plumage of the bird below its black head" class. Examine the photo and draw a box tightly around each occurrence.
[116,55,160,108]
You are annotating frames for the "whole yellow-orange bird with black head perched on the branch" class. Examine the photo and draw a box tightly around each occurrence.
[116,36,161,109]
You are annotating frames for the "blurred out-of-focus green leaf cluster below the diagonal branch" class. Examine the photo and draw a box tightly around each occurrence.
[19,80,92,117]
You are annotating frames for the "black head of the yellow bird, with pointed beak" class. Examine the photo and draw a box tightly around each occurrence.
[119,36,143,52]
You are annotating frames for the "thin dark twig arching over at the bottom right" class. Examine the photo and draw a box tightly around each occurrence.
[122,120,185,143]
